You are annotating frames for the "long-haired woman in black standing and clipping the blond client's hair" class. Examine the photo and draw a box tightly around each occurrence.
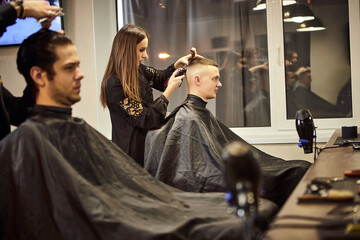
[100,24,191,166]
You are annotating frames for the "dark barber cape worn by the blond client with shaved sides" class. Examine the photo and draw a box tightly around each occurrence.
[145,95,311,206]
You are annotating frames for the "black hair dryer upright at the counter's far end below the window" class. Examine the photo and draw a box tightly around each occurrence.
[295,109,315,153]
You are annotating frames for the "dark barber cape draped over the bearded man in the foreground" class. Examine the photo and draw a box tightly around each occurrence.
[0,105,274,240]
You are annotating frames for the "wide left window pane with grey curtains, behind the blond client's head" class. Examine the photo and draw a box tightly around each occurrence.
[123,0,270,127]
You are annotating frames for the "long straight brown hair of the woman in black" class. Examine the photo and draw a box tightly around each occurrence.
[100,24,149,108]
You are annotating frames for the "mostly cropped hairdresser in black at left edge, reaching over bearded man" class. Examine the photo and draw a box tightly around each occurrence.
[0,0,60,140]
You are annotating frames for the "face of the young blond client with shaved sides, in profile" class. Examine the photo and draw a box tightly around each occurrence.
[200,66,222,101]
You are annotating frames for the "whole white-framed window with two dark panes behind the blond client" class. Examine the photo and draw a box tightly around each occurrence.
[118,0,360,143]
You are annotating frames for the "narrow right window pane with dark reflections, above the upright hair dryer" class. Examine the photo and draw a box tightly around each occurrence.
[283,0,352,119]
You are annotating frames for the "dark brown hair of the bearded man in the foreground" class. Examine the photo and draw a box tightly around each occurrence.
[16,28,73,94]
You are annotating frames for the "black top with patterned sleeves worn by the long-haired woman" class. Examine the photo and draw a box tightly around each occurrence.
[106,64,175,166]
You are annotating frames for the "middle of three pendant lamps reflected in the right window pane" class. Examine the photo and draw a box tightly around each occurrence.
[284,4,315,23]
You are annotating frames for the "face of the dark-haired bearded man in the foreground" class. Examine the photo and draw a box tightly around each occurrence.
[48,45,84,107]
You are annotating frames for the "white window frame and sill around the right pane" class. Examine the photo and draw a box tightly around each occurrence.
[231,0,360,144]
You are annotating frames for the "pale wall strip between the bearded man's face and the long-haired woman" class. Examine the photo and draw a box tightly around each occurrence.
[63,0,99,128]
